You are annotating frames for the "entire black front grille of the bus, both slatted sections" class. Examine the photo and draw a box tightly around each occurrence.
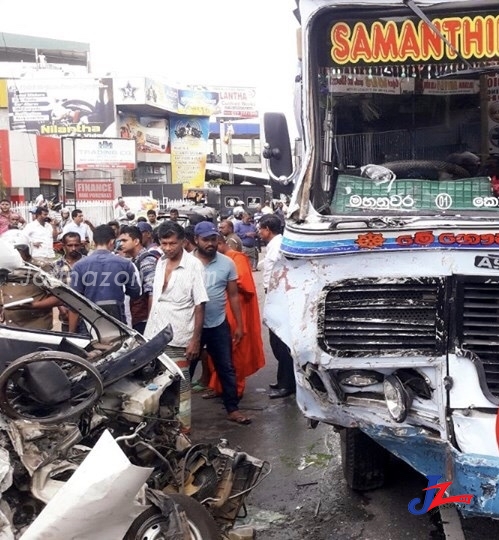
[318,276,499,404]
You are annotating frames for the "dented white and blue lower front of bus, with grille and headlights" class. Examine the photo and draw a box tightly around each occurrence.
[264,248,499,518]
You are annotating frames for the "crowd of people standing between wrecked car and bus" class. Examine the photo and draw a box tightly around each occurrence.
[0,194,295,433]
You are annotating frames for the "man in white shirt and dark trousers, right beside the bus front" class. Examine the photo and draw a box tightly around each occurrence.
[258,214,296,399]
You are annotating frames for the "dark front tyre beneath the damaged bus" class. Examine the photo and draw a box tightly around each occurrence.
[340,428,390,491]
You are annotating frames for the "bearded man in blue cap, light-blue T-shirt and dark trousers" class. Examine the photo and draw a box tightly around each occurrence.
[190,221,251,424]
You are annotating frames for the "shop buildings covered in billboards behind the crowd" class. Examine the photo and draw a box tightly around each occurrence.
[0,35,258,205]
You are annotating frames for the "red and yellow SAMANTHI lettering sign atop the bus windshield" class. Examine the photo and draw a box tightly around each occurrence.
[328,12,499,66]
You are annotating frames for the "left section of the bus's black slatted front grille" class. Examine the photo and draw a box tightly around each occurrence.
[319,278,444,357]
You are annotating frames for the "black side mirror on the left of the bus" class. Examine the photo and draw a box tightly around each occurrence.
[262,113,294,185]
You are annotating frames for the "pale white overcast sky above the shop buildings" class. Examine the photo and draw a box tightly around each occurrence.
[0,0,298,119]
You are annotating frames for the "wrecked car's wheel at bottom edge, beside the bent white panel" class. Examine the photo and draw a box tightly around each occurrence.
[124,493,221,540]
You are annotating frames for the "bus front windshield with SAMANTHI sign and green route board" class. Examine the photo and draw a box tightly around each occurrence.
[310,4,499,217]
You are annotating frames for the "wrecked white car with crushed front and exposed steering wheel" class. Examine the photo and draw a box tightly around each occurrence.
[0,242,268,540]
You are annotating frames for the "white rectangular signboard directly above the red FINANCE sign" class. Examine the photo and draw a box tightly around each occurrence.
[74,139,137,171]
